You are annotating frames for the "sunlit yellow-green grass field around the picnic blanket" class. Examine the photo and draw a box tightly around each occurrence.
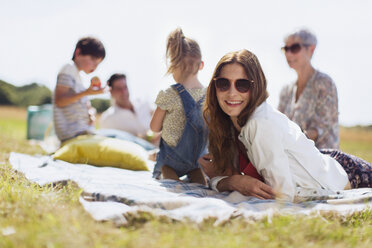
[0,107,372,248]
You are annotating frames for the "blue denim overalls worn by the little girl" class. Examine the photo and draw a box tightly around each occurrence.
[153,83,208,179]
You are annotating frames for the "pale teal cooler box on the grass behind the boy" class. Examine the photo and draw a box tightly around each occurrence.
[27,104,53,140]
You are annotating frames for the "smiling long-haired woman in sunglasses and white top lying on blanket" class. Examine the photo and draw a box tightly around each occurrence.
[199,50,372,200]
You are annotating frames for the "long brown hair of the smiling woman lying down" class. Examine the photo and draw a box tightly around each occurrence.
[203,49,268,172]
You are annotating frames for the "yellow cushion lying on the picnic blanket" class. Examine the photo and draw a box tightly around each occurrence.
[53,135,149,170]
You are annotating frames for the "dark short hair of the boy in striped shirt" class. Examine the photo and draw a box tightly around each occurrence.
[72,37,106,60]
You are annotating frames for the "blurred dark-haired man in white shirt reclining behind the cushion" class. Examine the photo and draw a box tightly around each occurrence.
[99,73,159,144]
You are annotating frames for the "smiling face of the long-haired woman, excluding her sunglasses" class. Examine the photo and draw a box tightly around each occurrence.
[216,63,250,120]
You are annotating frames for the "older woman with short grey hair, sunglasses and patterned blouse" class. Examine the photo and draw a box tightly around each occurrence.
[278,29,339,149]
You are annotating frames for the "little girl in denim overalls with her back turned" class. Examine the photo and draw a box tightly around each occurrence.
[150,28,208,184]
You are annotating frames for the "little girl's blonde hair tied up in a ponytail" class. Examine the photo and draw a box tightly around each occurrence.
[166,28,201,79]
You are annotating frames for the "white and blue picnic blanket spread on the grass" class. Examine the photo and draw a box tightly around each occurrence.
[9,153,372,225]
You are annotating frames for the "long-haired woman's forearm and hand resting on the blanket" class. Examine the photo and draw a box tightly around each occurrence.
[217,175,275,199]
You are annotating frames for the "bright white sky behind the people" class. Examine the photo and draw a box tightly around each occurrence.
[0,0,372,126]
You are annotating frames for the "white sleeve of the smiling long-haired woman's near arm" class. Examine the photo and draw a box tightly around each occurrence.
[240,119,295,201]
